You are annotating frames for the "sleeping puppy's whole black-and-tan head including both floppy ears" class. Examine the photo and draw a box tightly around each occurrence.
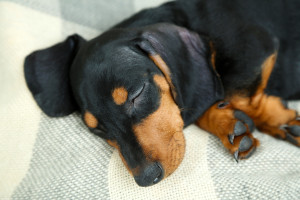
[25,24,222,186]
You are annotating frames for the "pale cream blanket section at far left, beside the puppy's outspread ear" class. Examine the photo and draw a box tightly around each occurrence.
[0,1,99,198]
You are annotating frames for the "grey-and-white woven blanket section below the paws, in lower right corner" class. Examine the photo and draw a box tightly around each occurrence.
[207,102,300,200]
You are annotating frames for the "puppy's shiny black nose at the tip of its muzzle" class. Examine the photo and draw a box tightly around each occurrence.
[134,162,164,187]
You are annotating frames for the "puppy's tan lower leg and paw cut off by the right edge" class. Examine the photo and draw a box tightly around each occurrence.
[231,53,300,146]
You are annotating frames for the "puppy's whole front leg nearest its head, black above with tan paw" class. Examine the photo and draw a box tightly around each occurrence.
[196,27,278,159]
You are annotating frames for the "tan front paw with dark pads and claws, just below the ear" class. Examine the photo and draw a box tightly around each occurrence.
[196,102,259,161]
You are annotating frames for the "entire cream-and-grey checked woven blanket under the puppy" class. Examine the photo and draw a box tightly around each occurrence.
[0,0,300,200]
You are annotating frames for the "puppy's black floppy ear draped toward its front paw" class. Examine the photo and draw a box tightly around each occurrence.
[137,24,224,126]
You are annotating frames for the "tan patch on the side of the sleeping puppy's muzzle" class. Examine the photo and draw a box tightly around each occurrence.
[133,76,185,178]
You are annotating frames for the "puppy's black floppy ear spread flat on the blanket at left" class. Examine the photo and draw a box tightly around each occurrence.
[24,34,85,117]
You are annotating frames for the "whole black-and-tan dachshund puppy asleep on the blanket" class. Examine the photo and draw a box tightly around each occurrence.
[25,0,300,186]
